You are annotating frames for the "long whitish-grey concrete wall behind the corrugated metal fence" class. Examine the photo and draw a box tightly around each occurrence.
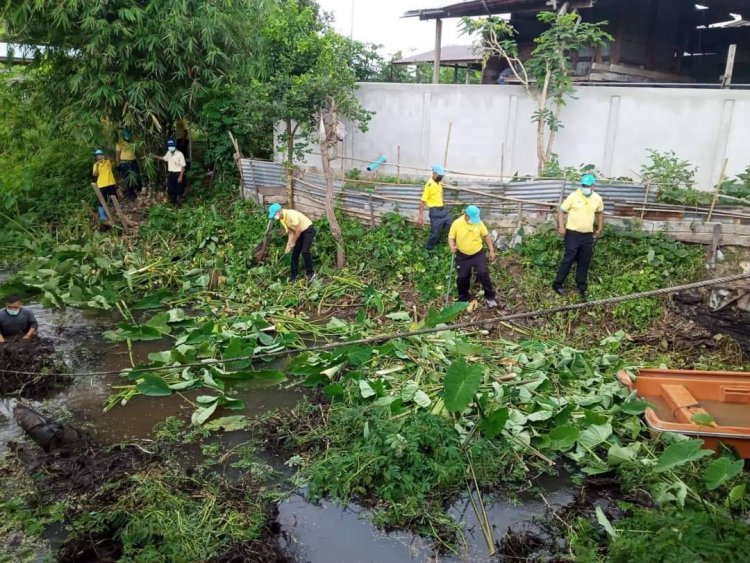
[338,83,750,189]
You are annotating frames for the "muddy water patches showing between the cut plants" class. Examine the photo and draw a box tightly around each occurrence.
[0,304,571,563]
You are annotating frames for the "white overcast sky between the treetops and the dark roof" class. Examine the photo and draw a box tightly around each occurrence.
[318,0,472,56]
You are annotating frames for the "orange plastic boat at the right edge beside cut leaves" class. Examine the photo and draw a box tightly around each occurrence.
[617,369,750,459]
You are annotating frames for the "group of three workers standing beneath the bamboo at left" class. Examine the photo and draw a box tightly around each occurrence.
[93,129,187,221]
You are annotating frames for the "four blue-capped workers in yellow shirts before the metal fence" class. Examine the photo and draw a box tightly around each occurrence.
[268,165,604,308]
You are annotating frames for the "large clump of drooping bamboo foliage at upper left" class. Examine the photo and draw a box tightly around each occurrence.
[0,0,269,161]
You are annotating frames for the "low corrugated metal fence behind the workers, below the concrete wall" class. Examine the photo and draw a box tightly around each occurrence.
[239,159,750,247]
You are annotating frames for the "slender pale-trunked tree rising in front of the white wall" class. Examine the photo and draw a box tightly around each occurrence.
[462,10,614,175]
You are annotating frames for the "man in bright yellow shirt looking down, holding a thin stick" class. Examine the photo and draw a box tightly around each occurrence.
[448,205,497,308]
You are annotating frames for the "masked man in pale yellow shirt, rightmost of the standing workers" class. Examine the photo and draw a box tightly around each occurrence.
[552,174,604,300]
